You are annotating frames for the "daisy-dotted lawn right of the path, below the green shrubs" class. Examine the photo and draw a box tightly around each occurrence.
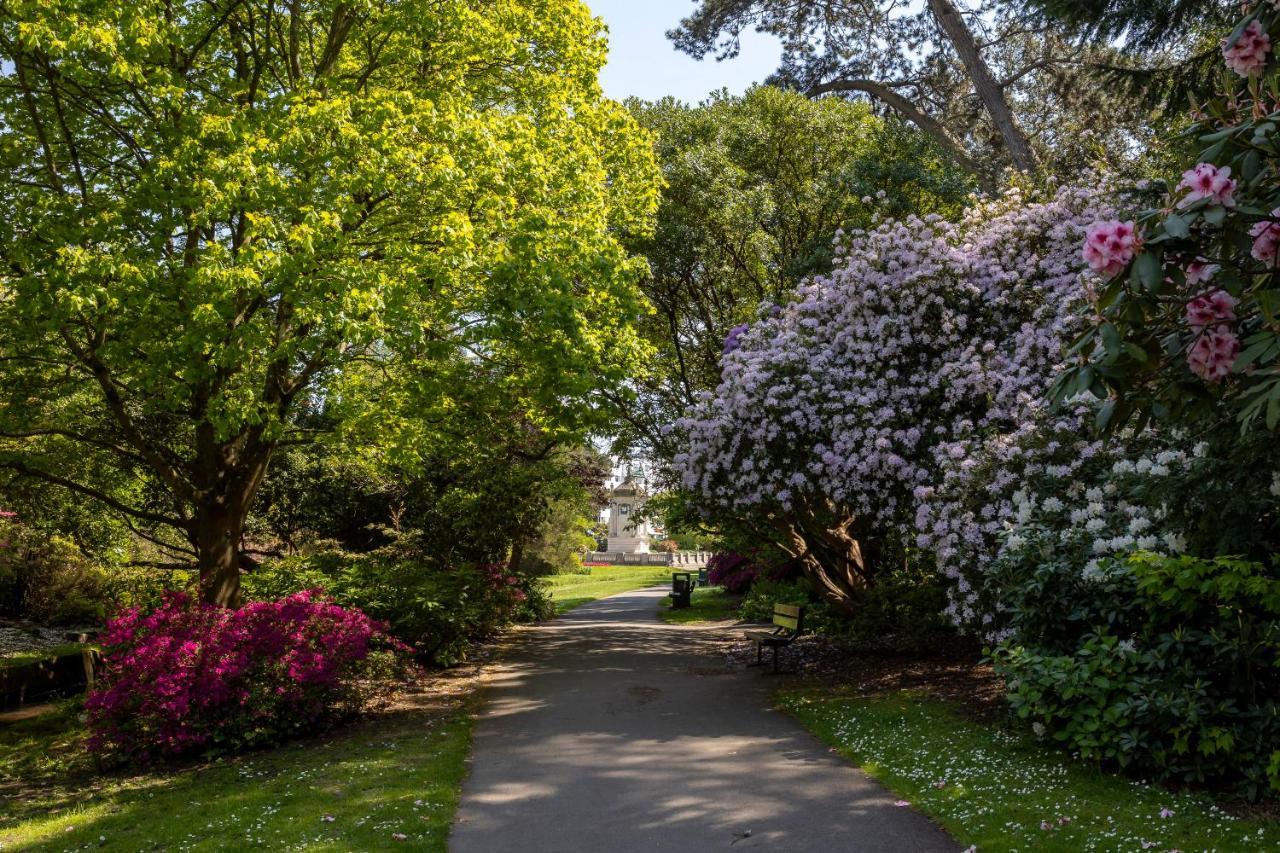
[780,690,1280,853]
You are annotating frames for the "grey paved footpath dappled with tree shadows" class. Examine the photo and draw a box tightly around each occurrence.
[449,589,959,853]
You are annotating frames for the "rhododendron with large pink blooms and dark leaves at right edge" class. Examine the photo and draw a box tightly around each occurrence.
[1053,3,1280,429]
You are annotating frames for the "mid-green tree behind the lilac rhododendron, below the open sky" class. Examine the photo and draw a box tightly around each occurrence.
[614,86,973,459]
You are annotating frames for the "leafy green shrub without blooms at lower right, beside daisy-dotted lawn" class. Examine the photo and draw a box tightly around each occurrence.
[993,553,1280,797]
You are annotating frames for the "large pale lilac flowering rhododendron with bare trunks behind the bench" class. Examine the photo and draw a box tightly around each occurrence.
[675,188,1111,611]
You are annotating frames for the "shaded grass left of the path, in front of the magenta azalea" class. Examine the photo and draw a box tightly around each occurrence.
[0,703,471,853]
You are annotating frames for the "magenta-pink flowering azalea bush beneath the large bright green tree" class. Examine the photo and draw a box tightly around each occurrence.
[84,590,398,763]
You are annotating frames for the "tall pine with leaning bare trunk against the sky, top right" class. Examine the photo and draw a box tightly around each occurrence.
[668,0,1172,176]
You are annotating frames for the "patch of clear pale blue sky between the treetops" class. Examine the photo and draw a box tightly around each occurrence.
[585,0,780,104]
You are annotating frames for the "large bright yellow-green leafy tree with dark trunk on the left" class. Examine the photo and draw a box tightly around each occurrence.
[0,0,655,605]
